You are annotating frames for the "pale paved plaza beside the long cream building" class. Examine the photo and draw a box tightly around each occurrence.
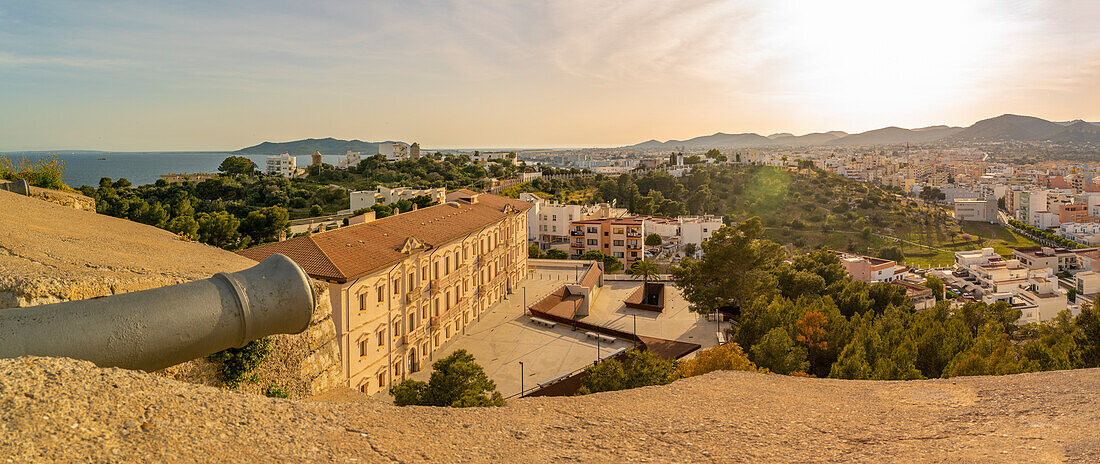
[413,267,726,397]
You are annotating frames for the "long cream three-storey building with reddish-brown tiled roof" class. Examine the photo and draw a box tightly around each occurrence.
[240,190,530,394]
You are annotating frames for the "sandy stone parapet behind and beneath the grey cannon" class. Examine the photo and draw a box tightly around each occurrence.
[0,190,341,398]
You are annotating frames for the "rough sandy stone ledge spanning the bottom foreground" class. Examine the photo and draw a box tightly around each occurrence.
[0,357,1100,463]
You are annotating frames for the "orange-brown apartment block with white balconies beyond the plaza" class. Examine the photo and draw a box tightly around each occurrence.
[570,218,646,267]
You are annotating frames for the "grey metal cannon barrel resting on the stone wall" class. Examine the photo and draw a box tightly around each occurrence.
[0,254,315,371]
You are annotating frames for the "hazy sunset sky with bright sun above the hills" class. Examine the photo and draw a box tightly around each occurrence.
[0,0,1100,151]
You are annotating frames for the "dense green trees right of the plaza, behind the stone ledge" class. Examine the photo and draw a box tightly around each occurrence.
[672,218,1100,379]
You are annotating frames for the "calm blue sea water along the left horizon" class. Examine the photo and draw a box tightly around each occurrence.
[0,152,342,188]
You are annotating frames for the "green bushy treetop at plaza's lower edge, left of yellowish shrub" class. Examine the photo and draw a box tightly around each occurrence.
[578,350,675,395]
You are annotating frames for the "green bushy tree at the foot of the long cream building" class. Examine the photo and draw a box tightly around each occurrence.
[389,350,504,408]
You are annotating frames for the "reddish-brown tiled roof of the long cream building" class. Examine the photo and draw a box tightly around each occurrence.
[238,194,531,283]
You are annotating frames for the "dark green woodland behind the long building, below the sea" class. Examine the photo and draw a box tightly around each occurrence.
[80,156,517,250]
